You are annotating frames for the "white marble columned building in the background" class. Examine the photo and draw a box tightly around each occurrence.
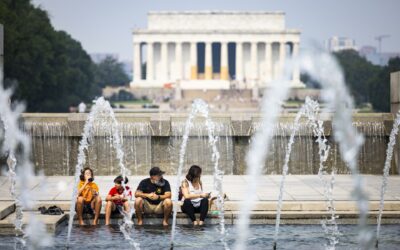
[131,11,304,89]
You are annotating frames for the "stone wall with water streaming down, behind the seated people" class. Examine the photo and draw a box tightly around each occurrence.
[9,113,397,175]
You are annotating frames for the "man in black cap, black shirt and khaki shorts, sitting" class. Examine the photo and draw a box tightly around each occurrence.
[135,167,172,226]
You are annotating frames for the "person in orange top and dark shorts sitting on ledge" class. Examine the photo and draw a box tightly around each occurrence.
[75,167,101,225]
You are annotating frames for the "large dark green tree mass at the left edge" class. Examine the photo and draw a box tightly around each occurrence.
[0,0,100,112]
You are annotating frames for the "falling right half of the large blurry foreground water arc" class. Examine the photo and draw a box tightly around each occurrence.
[297,48,373,249]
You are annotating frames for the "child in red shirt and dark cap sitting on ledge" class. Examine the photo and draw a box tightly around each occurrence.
[106,175,132,225]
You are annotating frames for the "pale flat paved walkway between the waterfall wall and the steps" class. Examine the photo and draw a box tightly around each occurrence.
[0,175,400,201]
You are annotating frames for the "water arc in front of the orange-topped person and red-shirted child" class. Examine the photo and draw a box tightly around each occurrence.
[67,97,139,249]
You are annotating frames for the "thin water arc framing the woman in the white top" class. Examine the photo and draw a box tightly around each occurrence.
[170,99,228,249]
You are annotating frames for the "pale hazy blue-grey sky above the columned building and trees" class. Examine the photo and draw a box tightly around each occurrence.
[33,0,400,60]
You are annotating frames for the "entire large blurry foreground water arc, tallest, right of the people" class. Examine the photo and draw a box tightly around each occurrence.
[235,47,372,249]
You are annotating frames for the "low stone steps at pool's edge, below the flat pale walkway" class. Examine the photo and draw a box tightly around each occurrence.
[0,201,400,235]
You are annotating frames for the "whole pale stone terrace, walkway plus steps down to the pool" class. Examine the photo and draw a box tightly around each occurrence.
[0,175,400,235]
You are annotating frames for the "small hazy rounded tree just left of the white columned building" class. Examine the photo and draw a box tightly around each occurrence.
[95,56,129,88]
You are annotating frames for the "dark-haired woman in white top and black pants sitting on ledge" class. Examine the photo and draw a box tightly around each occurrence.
[181,165,210,226]
